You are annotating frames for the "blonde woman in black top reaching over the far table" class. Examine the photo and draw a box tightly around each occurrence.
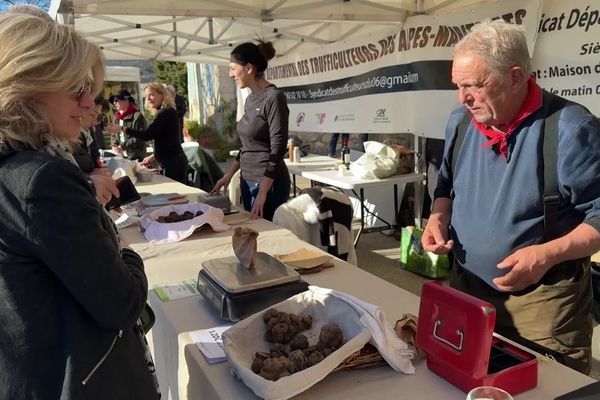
[111,82,188,184]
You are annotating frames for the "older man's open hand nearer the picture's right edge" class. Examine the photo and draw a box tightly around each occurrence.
[493,245,552,292]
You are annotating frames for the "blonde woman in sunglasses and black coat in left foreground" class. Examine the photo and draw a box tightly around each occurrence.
[0,13,159,400]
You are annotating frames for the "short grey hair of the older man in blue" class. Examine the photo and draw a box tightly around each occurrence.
[454,19,531,76]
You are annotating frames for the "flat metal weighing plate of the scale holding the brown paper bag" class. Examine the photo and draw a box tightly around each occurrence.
[202,252,300,293]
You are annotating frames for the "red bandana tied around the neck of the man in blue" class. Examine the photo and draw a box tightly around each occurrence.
[473,77,542,158]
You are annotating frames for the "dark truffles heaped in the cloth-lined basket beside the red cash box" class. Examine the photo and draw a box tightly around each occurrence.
[251,308,344,381]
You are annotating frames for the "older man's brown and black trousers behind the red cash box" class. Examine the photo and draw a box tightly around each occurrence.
[450,260,592,374]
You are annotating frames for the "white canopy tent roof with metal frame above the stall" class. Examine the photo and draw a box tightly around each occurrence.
[49,0,497,64]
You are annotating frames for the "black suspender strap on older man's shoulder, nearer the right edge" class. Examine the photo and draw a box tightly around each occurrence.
[541,94,567,240]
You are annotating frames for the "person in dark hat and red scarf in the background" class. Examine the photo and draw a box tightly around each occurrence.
[107,89,148,161]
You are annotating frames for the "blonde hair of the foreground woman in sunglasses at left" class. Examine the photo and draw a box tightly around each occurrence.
[0,13,104,150]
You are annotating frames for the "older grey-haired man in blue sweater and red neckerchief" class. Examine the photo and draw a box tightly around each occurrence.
[422,20,600,373]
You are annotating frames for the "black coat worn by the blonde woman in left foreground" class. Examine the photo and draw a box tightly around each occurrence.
[0,151,157,400]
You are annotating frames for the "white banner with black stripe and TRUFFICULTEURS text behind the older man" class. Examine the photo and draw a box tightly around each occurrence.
[267,0,541,138]
